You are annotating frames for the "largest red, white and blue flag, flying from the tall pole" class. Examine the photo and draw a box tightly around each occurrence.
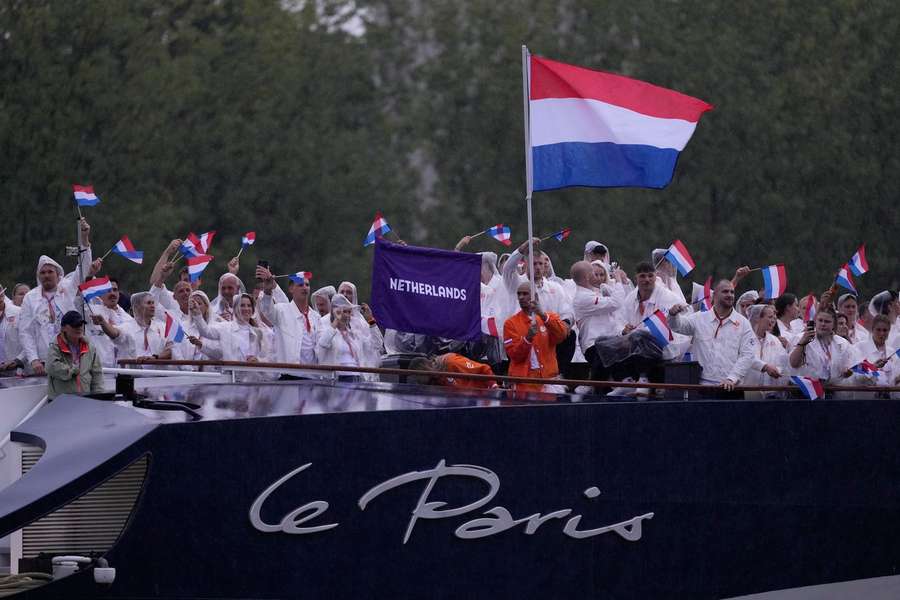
[528,56,713,191]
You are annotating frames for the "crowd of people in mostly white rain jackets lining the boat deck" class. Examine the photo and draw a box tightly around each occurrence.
[0,219,900,397]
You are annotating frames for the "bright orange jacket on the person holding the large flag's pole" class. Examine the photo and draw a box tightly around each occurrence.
[503,310,569,391]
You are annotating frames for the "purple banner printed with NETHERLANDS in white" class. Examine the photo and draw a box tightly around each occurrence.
[372,238,481,340]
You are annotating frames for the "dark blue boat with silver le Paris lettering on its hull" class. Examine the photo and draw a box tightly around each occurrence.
[0,368,900,600]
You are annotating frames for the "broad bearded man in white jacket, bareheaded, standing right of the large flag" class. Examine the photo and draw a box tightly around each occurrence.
[669,279,757,398]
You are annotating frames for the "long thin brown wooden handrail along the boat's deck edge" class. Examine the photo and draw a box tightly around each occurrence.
[119,358,900,392]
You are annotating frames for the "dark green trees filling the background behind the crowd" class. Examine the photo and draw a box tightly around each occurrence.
[0,0,900,296]
